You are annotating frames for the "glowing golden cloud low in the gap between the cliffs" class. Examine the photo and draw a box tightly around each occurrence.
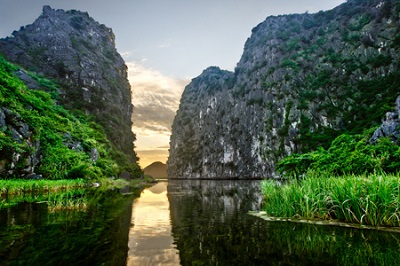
[127,62,190,167]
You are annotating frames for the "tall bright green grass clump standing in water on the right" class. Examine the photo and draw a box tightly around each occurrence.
[262,173,400,226]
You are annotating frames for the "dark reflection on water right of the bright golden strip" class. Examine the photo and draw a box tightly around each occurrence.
[168,180,400,265]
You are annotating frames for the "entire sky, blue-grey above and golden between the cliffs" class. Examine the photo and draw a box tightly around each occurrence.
[0,0,345,167]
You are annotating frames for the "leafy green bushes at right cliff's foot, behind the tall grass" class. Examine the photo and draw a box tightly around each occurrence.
[277,130,400,177]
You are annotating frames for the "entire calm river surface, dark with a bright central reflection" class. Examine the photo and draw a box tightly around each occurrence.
[0,180,400,266]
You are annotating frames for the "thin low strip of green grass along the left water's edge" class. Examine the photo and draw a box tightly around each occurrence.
[0,179,87,196]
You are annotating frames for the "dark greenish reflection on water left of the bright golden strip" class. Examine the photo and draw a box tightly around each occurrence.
[0,191,138,266]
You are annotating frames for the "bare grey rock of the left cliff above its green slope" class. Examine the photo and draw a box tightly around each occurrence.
[0,6,136,163]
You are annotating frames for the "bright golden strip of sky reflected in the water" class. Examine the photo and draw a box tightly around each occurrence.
[128,182,179,266]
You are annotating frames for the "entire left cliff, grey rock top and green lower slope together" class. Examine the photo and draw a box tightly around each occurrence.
[0,6,141,179]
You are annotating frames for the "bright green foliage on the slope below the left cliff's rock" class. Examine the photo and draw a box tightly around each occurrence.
[0,57,141,179]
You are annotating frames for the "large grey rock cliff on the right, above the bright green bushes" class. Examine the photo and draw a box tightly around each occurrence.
[168,0,400,178]
